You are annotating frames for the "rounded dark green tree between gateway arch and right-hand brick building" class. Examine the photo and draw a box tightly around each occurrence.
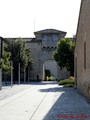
[54,38,75,76]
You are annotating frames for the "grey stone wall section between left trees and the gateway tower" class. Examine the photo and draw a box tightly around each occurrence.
[26,42,42,80]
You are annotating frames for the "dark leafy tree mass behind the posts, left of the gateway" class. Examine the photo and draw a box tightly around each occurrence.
[6,38,32,82]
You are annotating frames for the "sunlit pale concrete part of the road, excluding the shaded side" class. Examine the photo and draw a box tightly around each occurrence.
[0,83,56,120]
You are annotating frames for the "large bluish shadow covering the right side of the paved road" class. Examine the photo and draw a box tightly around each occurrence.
[40,87,90,120]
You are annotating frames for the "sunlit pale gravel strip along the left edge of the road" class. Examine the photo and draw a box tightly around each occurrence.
[0,84,31,100]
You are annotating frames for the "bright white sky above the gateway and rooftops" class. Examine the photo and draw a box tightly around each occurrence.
[0,0,81,37]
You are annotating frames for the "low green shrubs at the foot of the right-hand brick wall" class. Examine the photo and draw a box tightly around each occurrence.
[58,77,75,87]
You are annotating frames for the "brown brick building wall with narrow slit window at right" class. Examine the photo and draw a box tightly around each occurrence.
[75,0,90,100]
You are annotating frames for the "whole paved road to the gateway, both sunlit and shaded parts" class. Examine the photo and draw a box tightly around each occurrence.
[0,82,90,120]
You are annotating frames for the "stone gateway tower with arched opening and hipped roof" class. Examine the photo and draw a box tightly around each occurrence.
[23,29,69,80]
